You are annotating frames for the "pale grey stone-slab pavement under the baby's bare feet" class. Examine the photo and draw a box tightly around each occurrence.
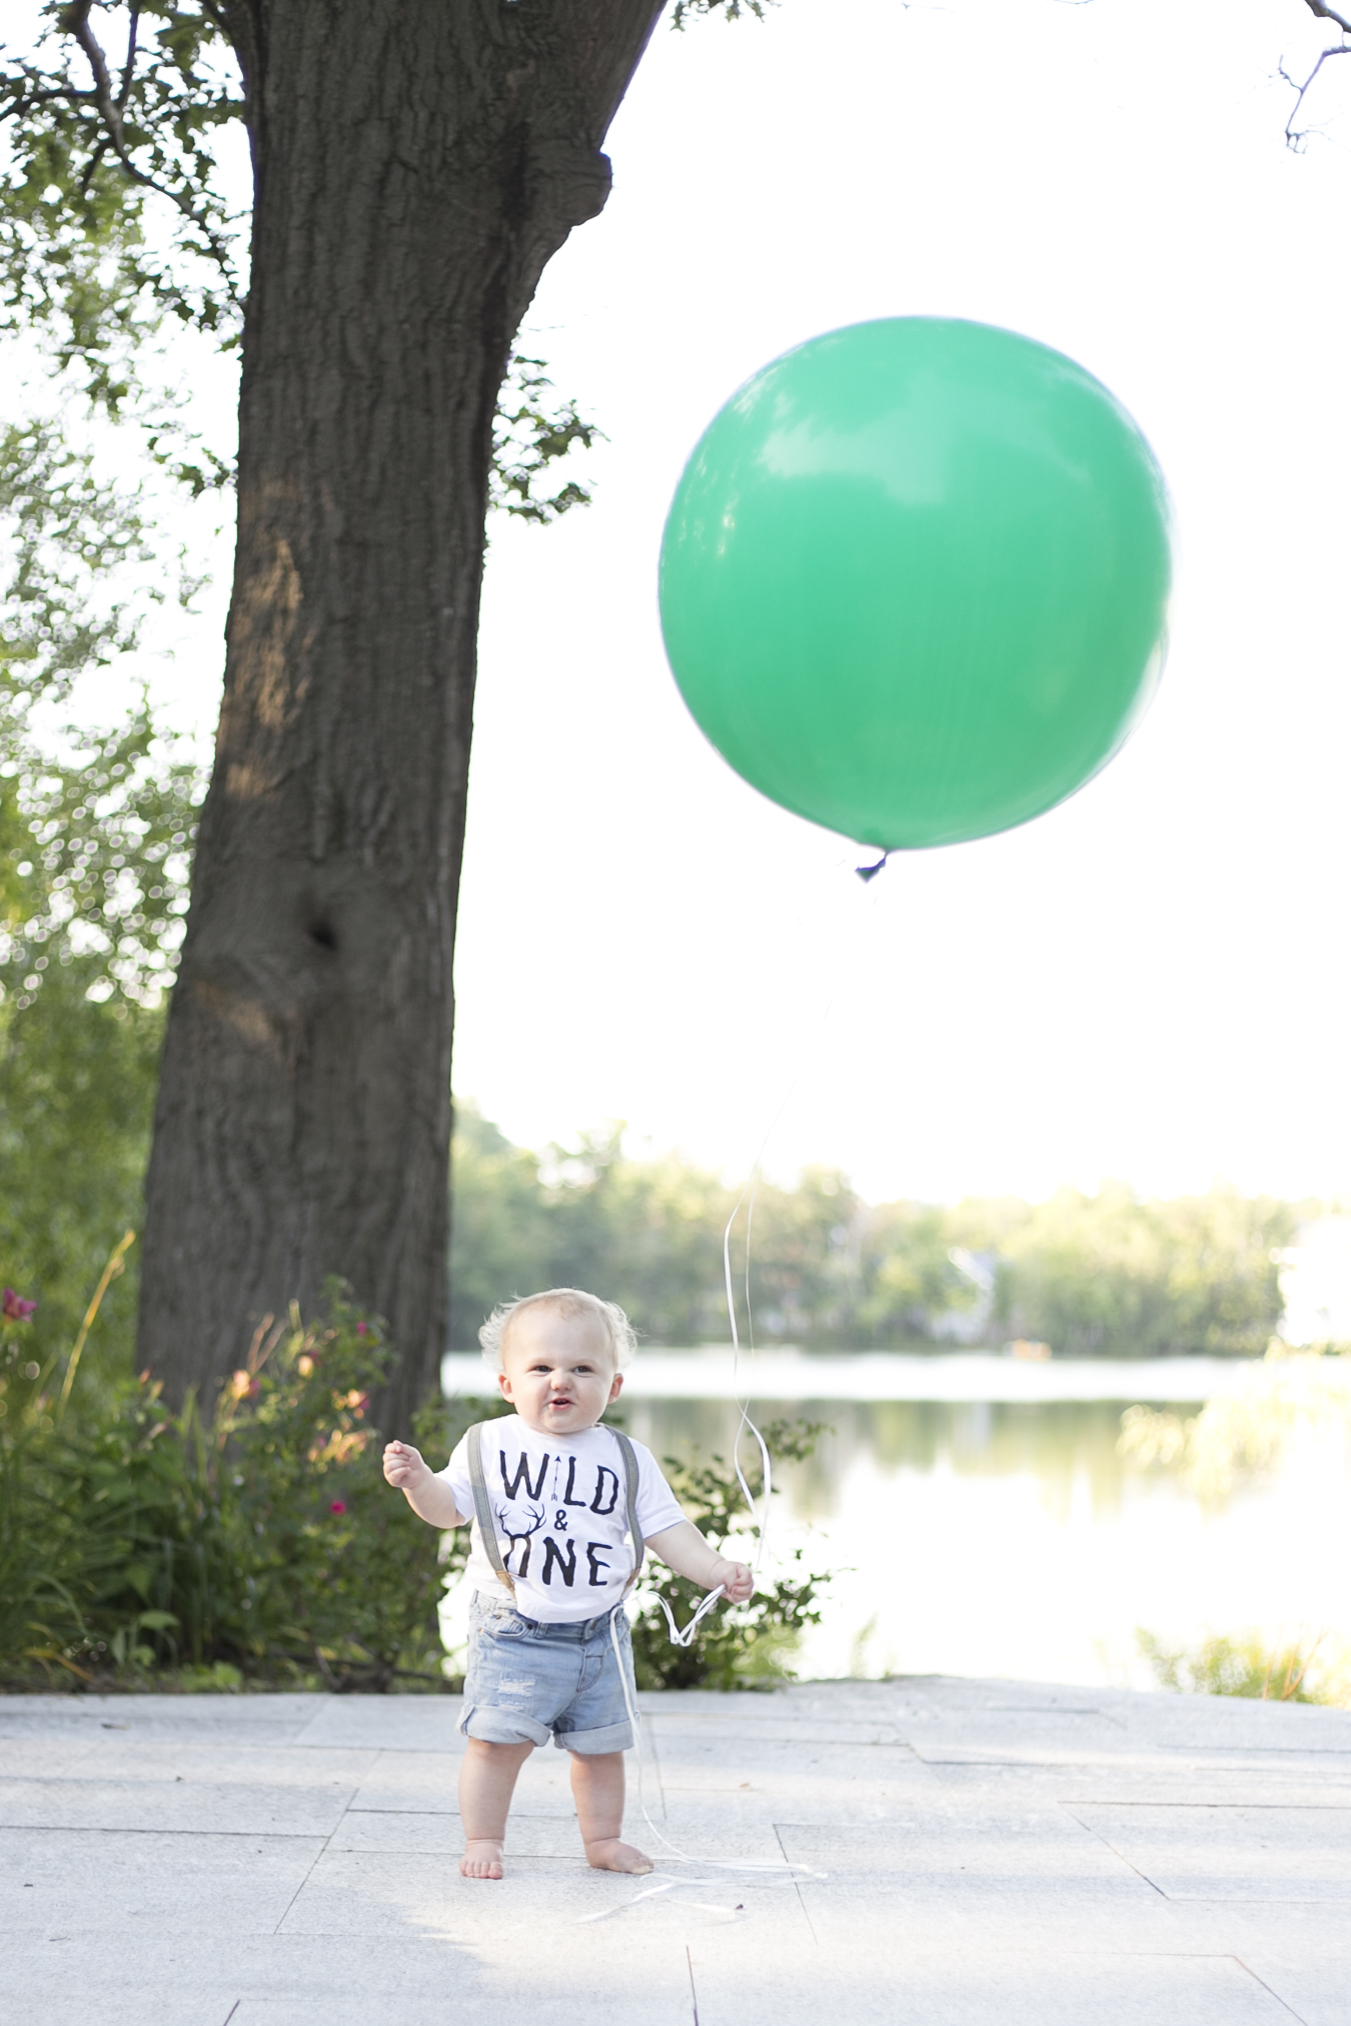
[0,1678,1351,2026]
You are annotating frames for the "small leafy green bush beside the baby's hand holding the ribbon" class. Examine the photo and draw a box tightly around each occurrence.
[634,1420,830,1690]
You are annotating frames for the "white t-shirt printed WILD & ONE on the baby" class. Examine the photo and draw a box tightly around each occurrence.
[440,1414,685,1625]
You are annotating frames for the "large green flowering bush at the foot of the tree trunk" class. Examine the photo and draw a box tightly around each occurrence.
[0,1291,478,1690]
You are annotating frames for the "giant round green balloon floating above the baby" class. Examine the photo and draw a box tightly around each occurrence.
[660,316,1169,851]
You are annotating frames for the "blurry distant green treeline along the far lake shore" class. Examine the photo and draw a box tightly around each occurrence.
[452,1104,1310,1357]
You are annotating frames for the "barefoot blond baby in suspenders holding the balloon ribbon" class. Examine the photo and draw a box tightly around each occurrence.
[385,1287,753,1878]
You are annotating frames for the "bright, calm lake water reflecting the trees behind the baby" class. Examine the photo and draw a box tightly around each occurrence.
[446,1351,1351,1688]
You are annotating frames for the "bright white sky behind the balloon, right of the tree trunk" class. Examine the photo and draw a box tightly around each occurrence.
[92,0,1351,1199]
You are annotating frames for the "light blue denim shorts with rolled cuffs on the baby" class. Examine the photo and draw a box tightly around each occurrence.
[460,1590,634,1752]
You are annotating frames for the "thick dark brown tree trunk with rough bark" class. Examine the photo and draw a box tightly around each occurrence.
[140,0,660,1430]
